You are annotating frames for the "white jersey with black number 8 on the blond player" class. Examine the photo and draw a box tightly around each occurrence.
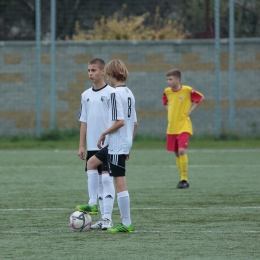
[108,85,137,154]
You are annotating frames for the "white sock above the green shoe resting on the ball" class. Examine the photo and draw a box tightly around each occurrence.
[87,170,98,206]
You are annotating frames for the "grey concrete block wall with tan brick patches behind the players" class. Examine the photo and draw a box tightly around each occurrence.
[0,39,260,136]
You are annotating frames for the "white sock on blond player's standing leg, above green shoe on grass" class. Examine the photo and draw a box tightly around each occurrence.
[117,190,132,226]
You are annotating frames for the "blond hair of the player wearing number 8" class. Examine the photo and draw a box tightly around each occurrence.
[105,60,129,82]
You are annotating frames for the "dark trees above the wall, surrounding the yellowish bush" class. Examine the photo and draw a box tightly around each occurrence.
[0,0,260,40]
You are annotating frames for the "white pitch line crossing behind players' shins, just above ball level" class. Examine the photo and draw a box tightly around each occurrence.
[0,206,260,212]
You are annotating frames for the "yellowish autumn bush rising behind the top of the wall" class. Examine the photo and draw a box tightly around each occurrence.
[73,5,185,41]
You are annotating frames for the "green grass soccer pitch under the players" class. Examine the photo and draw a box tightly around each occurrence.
[0,149,260,260]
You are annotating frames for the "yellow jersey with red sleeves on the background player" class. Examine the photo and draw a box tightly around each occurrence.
[162,85,203,134]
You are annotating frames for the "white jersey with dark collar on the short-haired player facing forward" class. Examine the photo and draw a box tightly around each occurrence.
[79,85,114,151]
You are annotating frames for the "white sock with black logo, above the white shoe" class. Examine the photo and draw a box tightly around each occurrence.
[102,173,115,220]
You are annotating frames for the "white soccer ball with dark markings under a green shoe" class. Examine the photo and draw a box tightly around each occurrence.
[69,211,92,232]
